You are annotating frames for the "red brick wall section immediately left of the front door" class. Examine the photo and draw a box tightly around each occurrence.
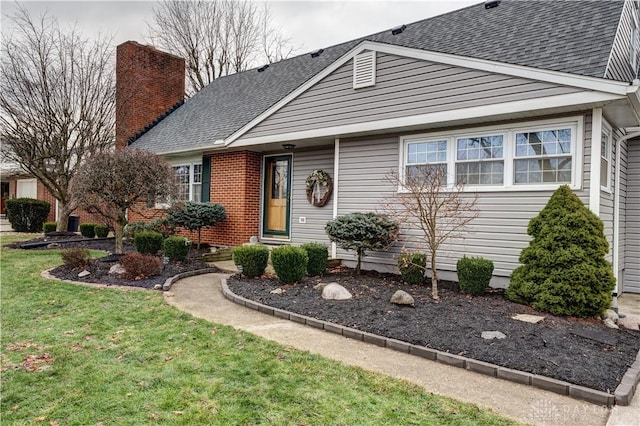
[129,151,262,246]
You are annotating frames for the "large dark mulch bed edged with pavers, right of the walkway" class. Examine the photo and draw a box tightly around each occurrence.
[228,268,640,393]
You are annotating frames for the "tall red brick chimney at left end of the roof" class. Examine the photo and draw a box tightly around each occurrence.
[116,41,185,149]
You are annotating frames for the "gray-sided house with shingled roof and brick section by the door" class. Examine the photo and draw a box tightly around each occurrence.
[118,0,640,293]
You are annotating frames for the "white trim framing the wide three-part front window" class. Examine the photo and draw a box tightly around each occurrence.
[398,116,584,193]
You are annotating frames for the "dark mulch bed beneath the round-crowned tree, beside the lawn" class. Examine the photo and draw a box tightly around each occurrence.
[7,234,216,289]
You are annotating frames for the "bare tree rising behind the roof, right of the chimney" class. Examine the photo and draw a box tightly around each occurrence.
[148,0,294,95]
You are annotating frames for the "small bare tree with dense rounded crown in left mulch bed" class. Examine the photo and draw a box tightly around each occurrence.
[71,148,177,253]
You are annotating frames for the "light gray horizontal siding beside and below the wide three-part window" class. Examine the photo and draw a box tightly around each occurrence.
[338,116,591,285]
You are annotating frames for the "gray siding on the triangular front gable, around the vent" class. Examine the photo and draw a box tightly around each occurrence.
[243,52,581,139]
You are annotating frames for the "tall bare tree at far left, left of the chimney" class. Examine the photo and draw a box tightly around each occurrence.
[0,9,115,231]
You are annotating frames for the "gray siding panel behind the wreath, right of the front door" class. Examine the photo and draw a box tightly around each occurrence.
[291,146,335,245]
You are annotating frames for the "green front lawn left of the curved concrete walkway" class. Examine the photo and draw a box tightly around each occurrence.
[0,238,512,425]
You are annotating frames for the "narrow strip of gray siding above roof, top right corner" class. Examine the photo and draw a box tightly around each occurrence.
[605,1,640,81]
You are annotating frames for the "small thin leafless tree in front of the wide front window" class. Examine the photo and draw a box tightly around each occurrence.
[384,165,478,300]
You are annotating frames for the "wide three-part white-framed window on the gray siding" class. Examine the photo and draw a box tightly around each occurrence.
[400,117,584,191]
